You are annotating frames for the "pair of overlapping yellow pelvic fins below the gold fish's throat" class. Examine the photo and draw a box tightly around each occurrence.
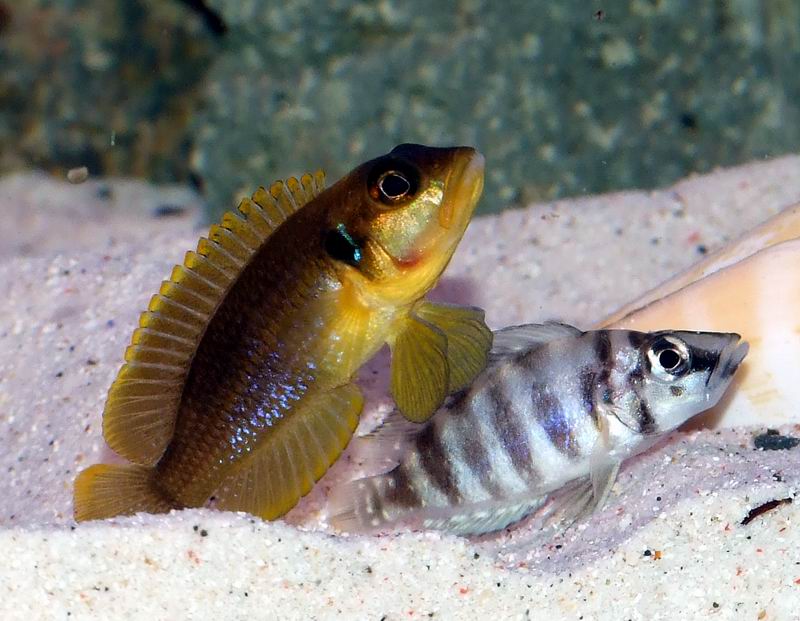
[390,302,492,423]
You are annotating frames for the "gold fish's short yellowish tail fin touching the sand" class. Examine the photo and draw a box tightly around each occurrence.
[74,464,178,522]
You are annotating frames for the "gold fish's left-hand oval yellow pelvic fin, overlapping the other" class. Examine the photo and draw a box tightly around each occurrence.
[389,315,450,423]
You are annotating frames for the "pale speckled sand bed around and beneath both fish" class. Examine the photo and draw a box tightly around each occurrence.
[0,157,800,621]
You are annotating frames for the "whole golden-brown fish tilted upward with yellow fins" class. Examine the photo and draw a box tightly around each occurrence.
[74,145,491,521]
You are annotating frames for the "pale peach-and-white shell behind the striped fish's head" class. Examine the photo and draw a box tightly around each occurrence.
[600,204,800,427]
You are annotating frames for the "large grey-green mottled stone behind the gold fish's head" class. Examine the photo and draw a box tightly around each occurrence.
[193,0,800,217]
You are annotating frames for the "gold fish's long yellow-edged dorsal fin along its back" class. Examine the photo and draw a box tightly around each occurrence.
[103,171,325,465]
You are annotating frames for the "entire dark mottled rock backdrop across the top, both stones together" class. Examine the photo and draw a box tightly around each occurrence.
[0,0,800,216]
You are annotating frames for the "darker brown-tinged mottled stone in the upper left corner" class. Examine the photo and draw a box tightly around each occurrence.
[0,0,215,182]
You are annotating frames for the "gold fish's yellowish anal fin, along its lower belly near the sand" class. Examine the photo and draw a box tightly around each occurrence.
[215,384,364,520]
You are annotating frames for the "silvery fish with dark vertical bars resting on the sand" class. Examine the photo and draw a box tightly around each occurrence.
[332,323,747,535]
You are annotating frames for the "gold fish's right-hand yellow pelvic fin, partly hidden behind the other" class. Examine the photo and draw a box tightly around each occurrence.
[414,301,492,393]
